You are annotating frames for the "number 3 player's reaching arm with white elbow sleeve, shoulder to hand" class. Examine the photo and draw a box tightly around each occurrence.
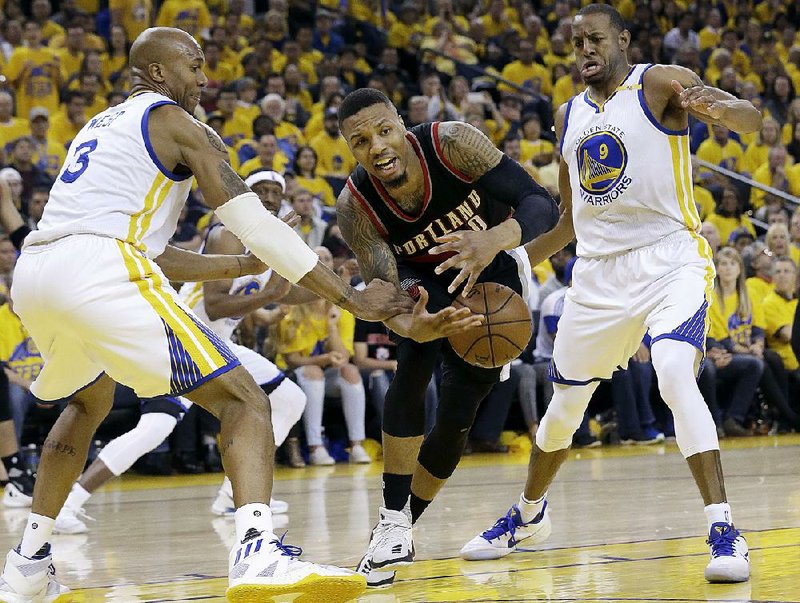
[149,105,413,320]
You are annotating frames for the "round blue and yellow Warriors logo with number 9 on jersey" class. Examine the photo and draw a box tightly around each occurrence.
[578,130,631,205]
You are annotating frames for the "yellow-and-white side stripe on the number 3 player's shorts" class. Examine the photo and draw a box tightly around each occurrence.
[117,241,228,375]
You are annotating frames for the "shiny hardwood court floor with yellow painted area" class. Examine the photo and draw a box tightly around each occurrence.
[0,436,800,603]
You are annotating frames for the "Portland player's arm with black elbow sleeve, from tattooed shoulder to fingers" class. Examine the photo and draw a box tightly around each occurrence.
[430,122,558,293]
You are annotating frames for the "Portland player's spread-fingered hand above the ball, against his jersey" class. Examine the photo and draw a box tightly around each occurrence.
[428,230,498,294]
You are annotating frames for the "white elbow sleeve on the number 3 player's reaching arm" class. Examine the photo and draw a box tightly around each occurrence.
[216,192,319,284]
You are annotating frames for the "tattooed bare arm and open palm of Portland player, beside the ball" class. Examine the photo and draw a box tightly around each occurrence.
[336,187,482,342]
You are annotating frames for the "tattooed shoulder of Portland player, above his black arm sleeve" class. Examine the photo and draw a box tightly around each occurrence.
[439,122,503,180]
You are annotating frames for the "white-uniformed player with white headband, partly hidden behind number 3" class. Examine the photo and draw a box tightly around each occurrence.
[54,170,310,534]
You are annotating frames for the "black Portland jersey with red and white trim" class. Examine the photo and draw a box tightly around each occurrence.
[347,122,512,265]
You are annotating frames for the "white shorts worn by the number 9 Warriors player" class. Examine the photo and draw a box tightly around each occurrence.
[549,231,715,385]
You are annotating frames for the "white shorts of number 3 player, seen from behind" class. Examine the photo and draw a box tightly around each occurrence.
[11,235,240,401]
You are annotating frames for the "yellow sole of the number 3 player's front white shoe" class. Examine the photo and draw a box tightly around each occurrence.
[226,574,367,603]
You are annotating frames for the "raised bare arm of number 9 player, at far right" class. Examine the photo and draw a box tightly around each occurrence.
[644,65,762,134]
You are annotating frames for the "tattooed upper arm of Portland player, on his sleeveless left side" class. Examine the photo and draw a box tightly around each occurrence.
[336,193,400,287]
